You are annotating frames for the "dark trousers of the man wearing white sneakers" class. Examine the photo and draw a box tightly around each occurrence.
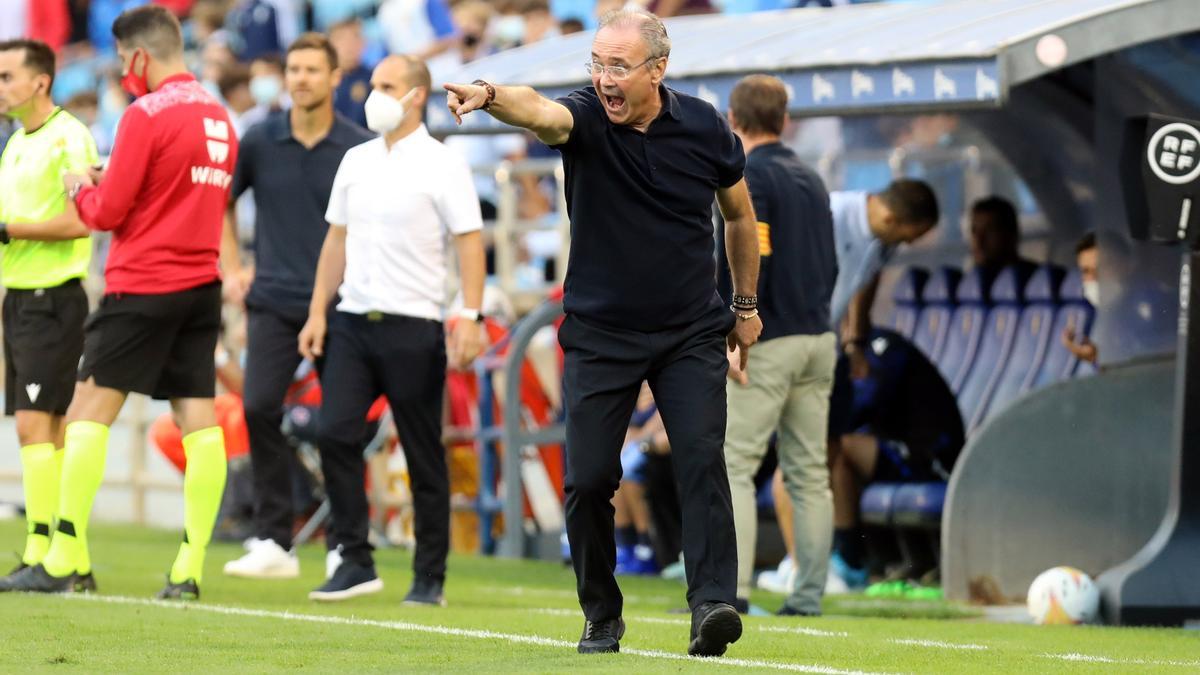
[242,306,307,550]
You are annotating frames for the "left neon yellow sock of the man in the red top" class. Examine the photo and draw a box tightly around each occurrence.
[42,422,108,577]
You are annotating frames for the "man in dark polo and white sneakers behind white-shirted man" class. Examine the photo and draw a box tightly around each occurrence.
[222,32,371,578]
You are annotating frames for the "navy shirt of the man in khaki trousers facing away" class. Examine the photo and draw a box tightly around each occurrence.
[716,143,838,340]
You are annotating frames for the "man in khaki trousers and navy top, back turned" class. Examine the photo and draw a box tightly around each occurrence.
[719,76,838,616]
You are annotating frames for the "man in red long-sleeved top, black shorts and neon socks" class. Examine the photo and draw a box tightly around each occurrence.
[0,5,238,599]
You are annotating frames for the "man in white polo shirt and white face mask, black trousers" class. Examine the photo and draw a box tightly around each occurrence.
[300,56,484,605]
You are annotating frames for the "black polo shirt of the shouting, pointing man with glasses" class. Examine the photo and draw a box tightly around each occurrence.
[557,86,745,331]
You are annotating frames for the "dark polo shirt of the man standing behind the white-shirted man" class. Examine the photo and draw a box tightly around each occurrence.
[233,110,374,313]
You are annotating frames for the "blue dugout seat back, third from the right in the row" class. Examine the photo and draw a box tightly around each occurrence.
[955,268,1025,432]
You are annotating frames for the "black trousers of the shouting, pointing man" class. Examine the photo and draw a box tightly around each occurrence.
[558,309,738,621]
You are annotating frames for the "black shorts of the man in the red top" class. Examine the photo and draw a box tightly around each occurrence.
[79,282,221,399]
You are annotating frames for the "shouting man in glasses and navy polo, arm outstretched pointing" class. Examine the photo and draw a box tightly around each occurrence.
[445,10,762,656]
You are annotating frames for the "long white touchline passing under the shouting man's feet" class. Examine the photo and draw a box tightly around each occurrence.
[60,593,892,675]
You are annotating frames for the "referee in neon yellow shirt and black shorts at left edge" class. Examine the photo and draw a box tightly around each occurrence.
[0,40,98,590]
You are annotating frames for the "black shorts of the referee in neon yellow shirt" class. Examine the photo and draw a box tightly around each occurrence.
[4,279,88,414]
